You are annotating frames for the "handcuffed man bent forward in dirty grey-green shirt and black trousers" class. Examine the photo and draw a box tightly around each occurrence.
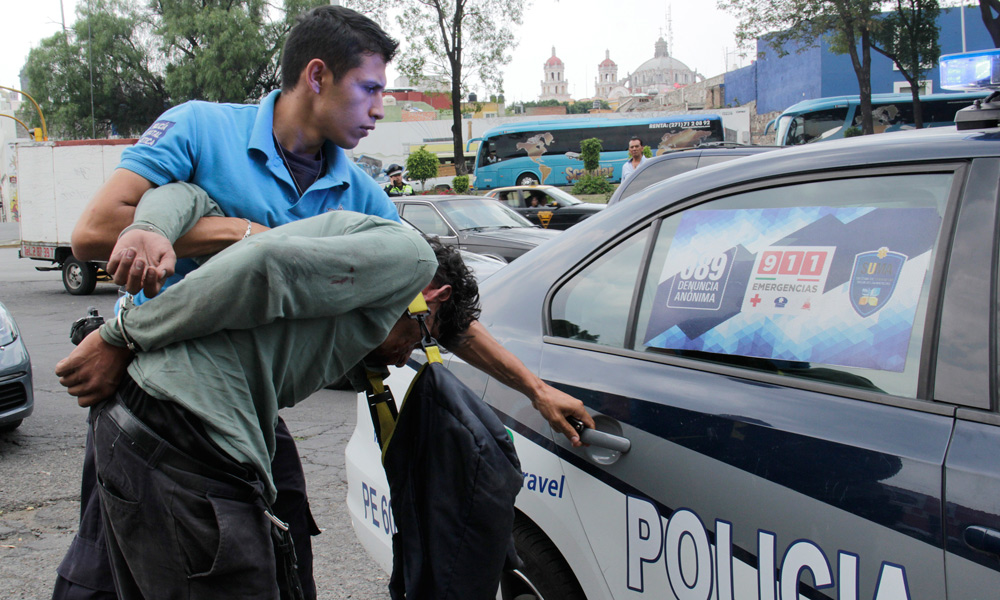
[56,183,478,600]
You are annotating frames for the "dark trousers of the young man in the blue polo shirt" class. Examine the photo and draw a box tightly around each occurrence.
[52,406,319,600]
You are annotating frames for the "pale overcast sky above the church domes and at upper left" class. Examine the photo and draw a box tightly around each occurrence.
[0,0,746,103]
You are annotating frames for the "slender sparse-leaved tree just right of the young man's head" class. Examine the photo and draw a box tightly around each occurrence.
[350,0,525,175]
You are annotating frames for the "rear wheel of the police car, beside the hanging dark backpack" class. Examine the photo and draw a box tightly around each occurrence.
[507,514,587,600]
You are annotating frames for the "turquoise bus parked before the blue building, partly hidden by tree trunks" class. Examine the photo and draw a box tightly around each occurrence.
[764,92,989,146]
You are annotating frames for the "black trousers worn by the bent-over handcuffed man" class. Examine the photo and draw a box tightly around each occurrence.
[91,395,278,600]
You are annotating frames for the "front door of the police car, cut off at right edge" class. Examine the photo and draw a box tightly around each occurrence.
[934,159,1000,598]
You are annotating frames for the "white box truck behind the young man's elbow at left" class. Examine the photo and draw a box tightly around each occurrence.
[11,139,135,295]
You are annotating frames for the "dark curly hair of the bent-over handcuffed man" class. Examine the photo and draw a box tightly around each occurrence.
[427,237,480,347]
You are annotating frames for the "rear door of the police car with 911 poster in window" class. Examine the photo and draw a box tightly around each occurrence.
[539,164,968,600]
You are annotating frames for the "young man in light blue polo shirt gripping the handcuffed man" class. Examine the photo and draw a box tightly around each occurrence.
[60,6,593,599]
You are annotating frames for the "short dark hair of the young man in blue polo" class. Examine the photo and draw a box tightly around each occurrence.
[281,5,399,92]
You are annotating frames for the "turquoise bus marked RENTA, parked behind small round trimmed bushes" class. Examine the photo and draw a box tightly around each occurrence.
[470,115,725,190]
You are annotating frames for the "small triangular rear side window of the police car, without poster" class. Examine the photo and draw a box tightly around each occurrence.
[551,228,649,348]
